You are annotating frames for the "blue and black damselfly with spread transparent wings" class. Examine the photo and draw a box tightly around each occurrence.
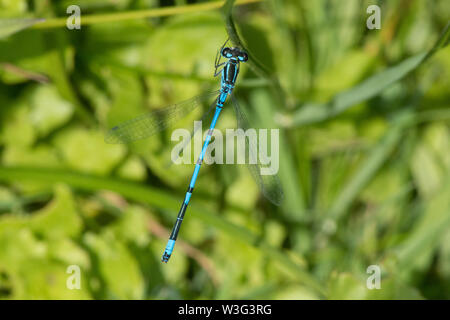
[105,41,283,263]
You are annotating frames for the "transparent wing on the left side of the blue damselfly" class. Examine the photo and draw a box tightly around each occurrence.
[105,91,219,143]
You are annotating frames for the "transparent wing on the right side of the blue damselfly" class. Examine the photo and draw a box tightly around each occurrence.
[231,95,284,206]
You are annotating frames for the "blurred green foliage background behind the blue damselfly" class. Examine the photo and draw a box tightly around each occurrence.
[0,0,450,299]
